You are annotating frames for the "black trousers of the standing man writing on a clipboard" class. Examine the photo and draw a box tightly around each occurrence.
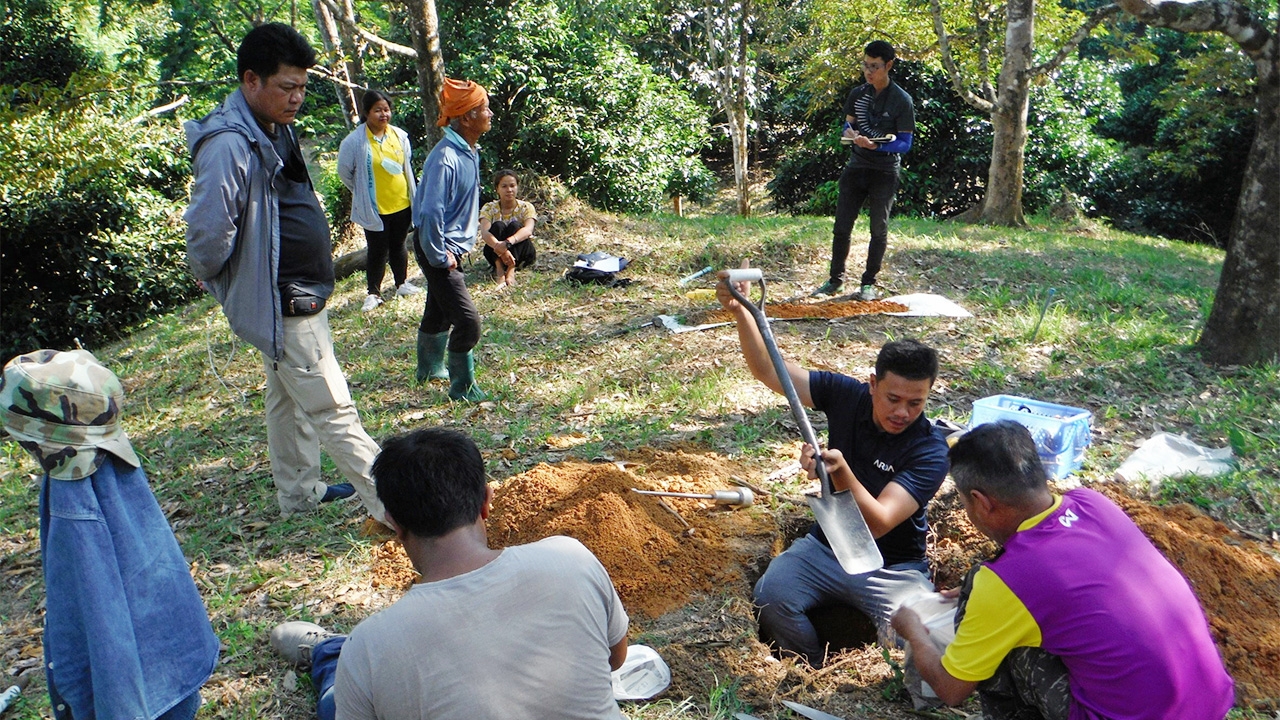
[831,163,897,284]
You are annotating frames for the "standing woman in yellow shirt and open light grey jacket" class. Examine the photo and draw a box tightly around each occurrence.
[338,90,422,313]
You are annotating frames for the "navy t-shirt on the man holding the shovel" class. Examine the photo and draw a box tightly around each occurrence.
[809,370,950,568]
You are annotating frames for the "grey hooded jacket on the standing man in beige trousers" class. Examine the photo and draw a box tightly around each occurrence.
[183,90,284,360]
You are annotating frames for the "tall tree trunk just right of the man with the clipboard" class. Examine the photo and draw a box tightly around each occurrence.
[975,0,1036,227]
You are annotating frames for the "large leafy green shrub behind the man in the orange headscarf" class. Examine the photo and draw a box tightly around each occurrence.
[424,0,712,211]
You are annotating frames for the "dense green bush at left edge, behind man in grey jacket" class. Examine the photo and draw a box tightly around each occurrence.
[0,78,198,360]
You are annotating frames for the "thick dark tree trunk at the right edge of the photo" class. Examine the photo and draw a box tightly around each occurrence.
[1197,54,1280,365]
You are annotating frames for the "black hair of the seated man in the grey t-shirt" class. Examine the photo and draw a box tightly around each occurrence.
[371,428,486,538]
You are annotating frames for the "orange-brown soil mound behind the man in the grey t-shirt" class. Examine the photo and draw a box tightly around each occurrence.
[372,448,774,618]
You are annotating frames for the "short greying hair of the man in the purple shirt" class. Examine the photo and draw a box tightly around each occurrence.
[950,420,1048,505]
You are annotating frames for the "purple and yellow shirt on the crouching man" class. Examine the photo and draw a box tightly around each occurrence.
[942,488,1234,720]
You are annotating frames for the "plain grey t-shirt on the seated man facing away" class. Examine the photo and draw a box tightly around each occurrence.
[334,537,627,720]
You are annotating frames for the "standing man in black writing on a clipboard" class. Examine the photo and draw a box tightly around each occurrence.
[813,40,915,300]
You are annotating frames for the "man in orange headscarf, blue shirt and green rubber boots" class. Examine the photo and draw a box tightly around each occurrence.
[413,78,494,402]
